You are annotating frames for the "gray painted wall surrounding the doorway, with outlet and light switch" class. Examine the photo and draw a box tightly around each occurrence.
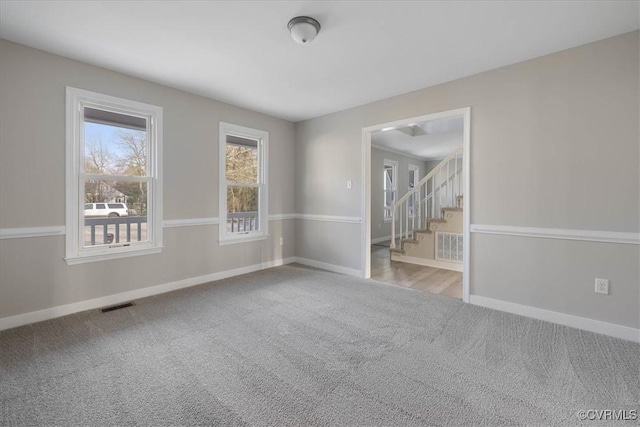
[296,31,640,328]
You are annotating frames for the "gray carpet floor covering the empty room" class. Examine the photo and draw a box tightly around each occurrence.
[0,265,640,426]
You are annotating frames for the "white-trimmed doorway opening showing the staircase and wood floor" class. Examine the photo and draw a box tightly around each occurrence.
[361,107,471,302]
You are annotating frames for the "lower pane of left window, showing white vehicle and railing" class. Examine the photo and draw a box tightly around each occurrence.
[80,180,149,248]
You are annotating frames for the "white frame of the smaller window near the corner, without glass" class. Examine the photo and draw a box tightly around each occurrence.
[218,121,269,245]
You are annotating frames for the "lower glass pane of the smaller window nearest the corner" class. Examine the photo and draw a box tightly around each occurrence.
[227,185,260,233]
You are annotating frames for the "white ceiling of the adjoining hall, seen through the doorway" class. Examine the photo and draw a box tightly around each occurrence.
[371,117,464,160]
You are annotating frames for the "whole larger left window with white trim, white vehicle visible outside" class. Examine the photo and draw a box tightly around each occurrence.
[65,87,162,264]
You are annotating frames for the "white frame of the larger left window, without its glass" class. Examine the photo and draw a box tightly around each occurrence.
[65,86,163,265]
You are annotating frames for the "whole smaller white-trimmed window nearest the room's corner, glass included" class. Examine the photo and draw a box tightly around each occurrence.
[219,122,269,244]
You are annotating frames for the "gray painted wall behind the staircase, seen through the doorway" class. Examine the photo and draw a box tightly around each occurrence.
[371,147,438,240]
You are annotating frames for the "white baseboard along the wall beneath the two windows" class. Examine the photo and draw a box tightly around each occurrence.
[0,257,296,331]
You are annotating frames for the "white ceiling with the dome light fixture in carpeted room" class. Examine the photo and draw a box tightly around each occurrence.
[0,0,640,121]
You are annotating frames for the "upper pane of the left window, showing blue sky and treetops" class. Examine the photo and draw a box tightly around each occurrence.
[83,108,147,176]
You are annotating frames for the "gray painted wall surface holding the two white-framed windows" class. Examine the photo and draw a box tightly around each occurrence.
[0,40,295,317]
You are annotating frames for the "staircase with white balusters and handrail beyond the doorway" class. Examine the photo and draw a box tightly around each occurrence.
[390,147,464,271]
